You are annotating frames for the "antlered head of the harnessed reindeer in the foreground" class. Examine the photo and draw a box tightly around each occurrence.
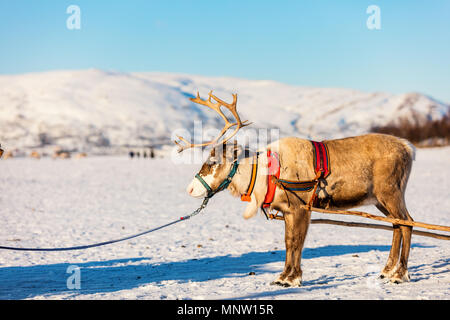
[175,91,250,198]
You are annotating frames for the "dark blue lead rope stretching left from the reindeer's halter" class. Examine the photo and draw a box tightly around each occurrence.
[0,197,210,251]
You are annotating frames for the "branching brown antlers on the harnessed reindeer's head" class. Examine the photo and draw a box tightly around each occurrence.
[175,90,251,152]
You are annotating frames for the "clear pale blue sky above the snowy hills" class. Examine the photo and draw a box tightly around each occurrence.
[0,0,450,102]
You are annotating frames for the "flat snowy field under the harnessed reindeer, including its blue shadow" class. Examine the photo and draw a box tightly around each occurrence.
[0,148,450,299]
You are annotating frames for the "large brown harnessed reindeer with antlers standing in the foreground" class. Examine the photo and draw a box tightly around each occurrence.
[175,92,415,287]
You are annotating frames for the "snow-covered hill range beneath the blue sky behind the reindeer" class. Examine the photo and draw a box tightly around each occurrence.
[0,69,450,151]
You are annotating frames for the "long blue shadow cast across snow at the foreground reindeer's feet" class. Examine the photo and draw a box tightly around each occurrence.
[0,244,436,299]
